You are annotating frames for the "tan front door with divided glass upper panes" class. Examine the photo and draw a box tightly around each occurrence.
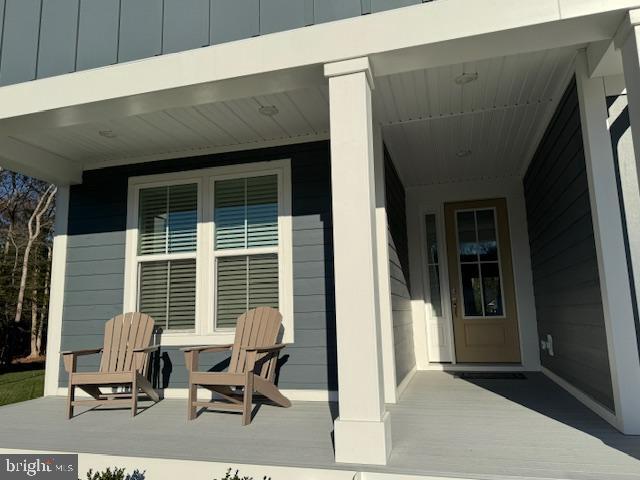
[445,199,520,363]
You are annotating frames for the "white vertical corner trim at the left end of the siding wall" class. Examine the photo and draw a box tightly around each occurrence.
[44,186,69,395]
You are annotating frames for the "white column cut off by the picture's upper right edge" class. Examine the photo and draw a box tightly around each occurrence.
[614,9,640,189]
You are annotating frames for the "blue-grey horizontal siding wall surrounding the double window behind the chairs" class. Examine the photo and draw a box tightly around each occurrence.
[60,142,337,390]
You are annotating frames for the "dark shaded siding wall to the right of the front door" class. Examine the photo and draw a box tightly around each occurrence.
[524,81,614,411]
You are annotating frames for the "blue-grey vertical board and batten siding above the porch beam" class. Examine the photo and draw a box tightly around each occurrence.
[0,0,433,85]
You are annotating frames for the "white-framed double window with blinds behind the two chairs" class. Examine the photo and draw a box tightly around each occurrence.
[124,160,293,345]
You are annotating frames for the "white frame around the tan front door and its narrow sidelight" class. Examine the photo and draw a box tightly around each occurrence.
[407,177,540,371]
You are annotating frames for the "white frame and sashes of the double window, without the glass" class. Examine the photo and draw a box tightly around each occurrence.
[123,159,294,346]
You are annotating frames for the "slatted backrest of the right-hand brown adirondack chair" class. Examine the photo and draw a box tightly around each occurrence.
[229,307,282,380]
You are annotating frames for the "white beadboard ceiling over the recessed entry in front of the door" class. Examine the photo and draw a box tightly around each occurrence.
[375,48,576,185]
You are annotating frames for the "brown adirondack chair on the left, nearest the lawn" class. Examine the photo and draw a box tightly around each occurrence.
[61,312,160,418]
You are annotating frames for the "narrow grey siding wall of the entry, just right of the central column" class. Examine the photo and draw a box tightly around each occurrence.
[384,148,416,384]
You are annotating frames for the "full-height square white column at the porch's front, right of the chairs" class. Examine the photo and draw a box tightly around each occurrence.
[325,58,391,465]
